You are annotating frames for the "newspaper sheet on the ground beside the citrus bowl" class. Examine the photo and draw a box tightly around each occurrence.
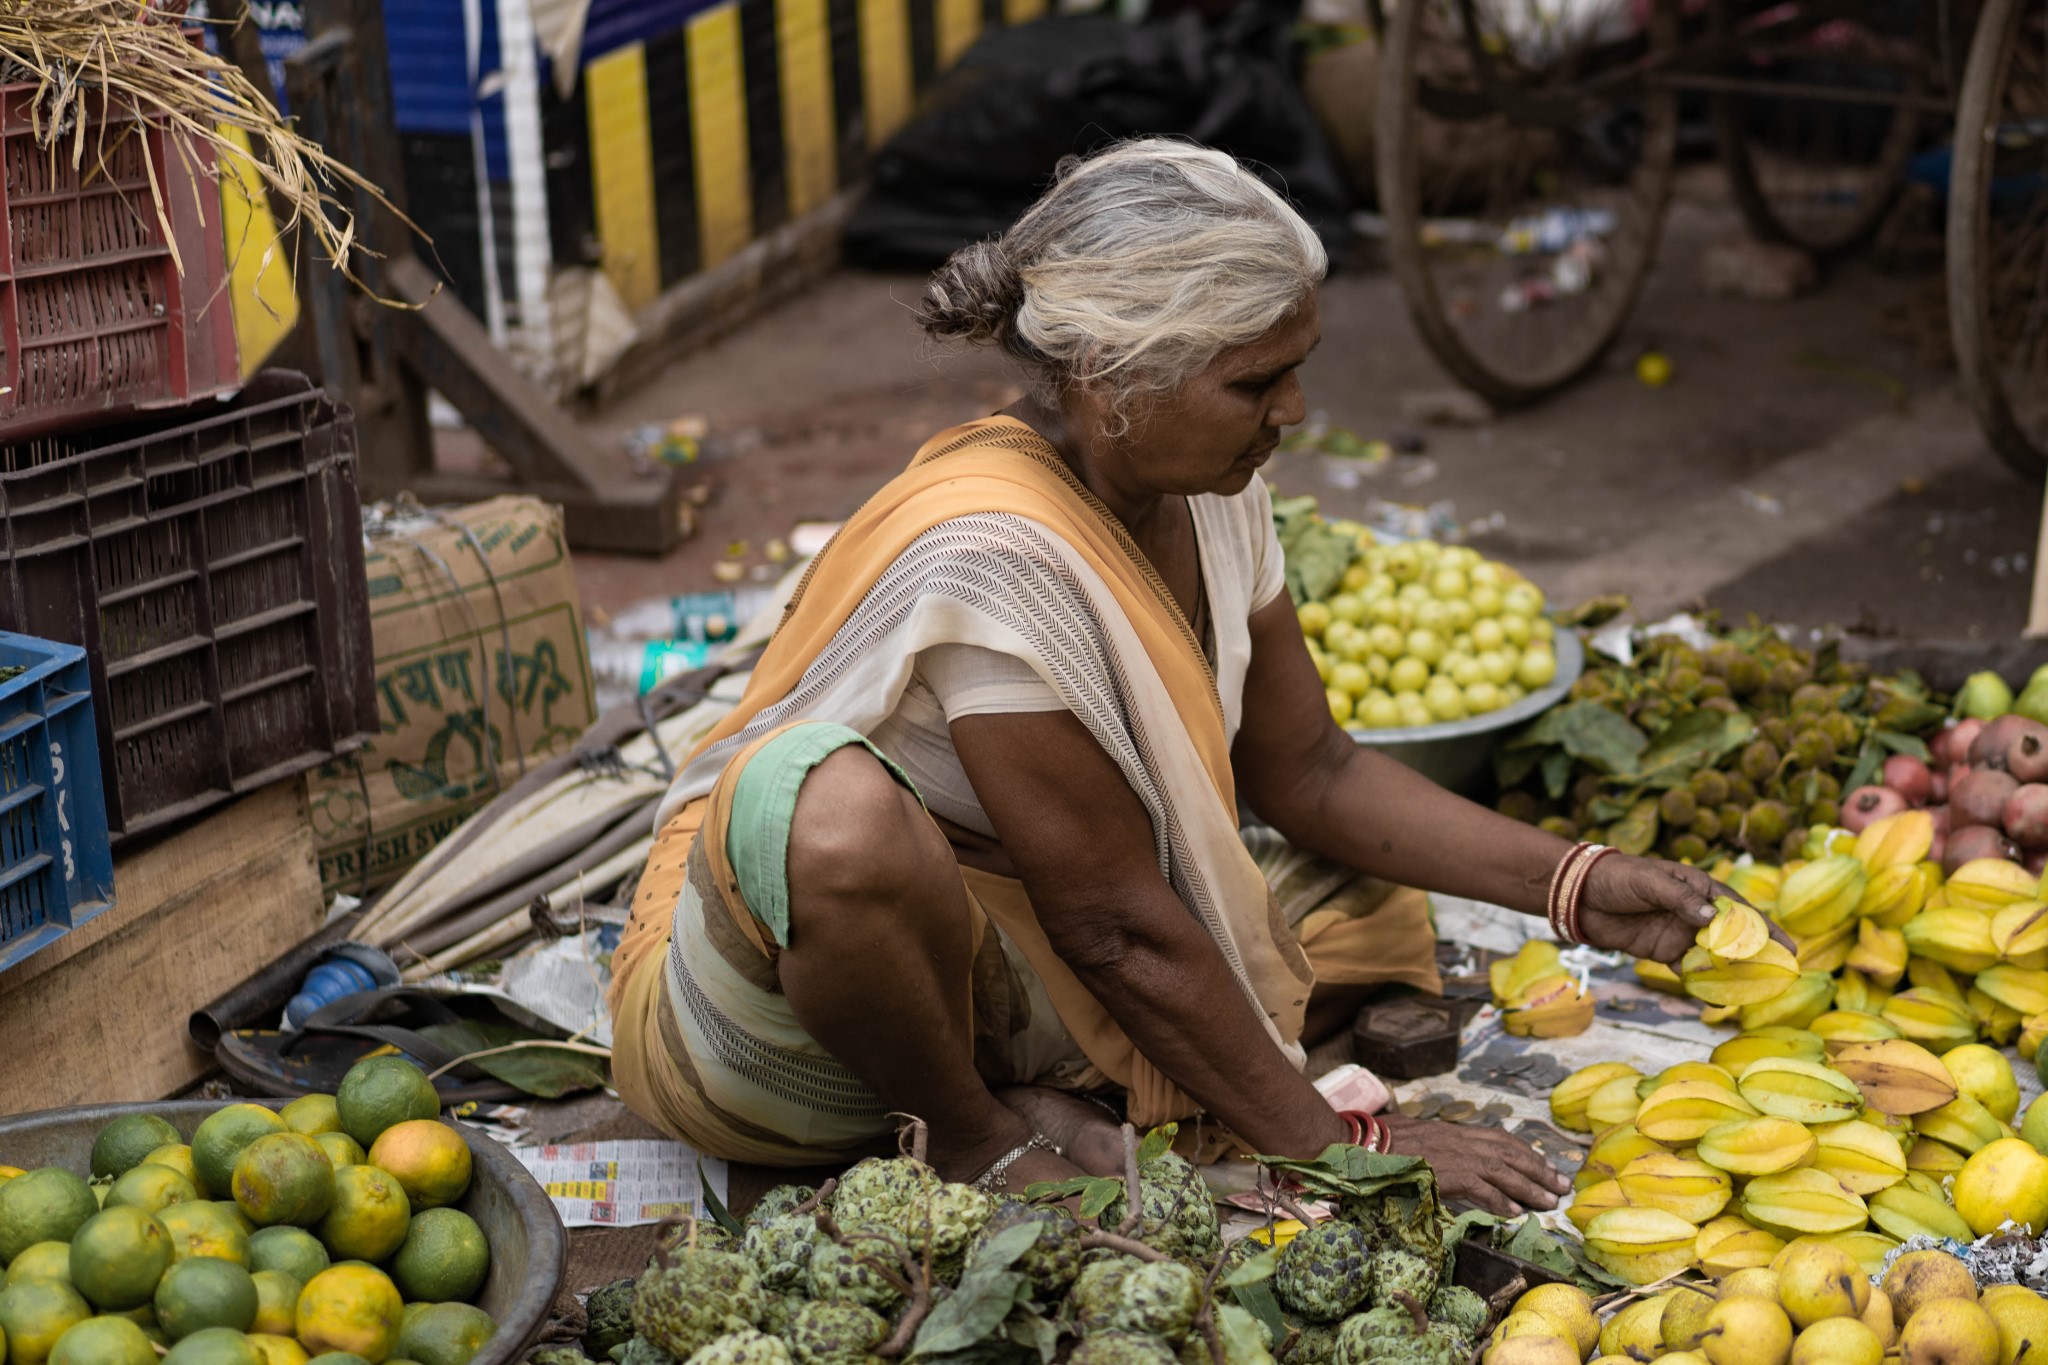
[512,1140,727,1228]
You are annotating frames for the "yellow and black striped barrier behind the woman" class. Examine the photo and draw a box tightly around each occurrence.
[541,0,1047,309]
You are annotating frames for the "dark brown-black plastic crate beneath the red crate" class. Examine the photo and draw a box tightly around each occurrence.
[0,370,377,839]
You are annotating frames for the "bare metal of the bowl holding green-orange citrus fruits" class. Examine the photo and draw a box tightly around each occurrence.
[0,1099,569,1365]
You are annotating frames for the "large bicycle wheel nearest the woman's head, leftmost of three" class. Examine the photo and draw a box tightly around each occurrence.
[1376,0,1677,403]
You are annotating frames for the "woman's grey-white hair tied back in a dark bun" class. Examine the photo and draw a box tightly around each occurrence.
[918,137,1329,436]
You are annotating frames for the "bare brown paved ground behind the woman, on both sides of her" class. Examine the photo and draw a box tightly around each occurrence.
[552,168,2040,639]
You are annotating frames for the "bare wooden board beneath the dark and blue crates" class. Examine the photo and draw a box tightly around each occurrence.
[0,778,322,1113]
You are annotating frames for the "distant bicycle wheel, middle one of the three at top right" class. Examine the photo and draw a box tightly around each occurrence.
[1712,0,1935,254]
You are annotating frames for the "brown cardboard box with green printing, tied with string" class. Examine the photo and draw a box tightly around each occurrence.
[307,497,598,894]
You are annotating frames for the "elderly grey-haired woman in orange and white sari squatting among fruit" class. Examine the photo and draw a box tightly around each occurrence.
[612,141,1718,1212]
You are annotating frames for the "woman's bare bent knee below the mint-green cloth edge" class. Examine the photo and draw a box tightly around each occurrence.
[788,745,956,911]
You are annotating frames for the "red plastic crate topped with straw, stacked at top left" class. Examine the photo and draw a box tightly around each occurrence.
[0,86,242,440]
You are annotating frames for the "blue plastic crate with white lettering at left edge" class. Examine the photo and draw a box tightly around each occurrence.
[0,630,115,972]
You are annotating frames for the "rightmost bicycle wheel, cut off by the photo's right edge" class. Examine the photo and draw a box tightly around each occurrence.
[1948,0,2048,479]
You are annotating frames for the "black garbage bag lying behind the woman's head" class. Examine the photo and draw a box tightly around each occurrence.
[844,0,1350,268]
